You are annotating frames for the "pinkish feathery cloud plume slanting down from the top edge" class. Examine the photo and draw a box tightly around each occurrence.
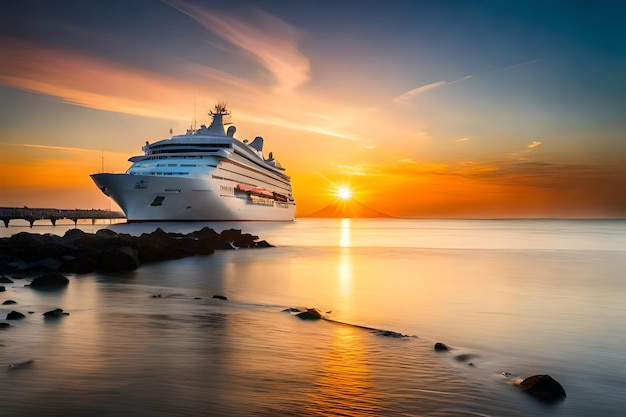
[166,0,309,91]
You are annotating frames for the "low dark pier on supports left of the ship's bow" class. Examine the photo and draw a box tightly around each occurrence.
[0,207,126,227]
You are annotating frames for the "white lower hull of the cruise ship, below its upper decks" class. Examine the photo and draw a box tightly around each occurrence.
[91,174,295,222]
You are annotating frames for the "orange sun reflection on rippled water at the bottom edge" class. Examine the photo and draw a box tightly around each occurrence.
[306,325,381,416]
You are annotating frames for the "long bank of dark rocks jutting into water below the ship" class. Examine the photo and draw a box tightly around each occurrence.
[0,227,272,277]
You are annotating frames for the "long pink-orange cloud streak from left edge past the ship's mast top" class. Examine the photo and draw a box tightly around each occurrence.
[0,36,346,139]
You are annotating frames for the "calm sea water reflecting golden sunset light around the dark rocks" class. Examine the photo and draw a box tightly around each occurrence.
[0,219,626,417]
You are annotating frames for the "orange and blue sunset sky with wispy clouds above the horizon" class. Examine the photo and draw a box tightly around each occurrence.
[0,0,626,218]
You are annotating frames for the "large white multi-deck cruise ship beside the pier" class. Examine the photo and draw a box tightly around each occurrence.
[90,103,296,222]
